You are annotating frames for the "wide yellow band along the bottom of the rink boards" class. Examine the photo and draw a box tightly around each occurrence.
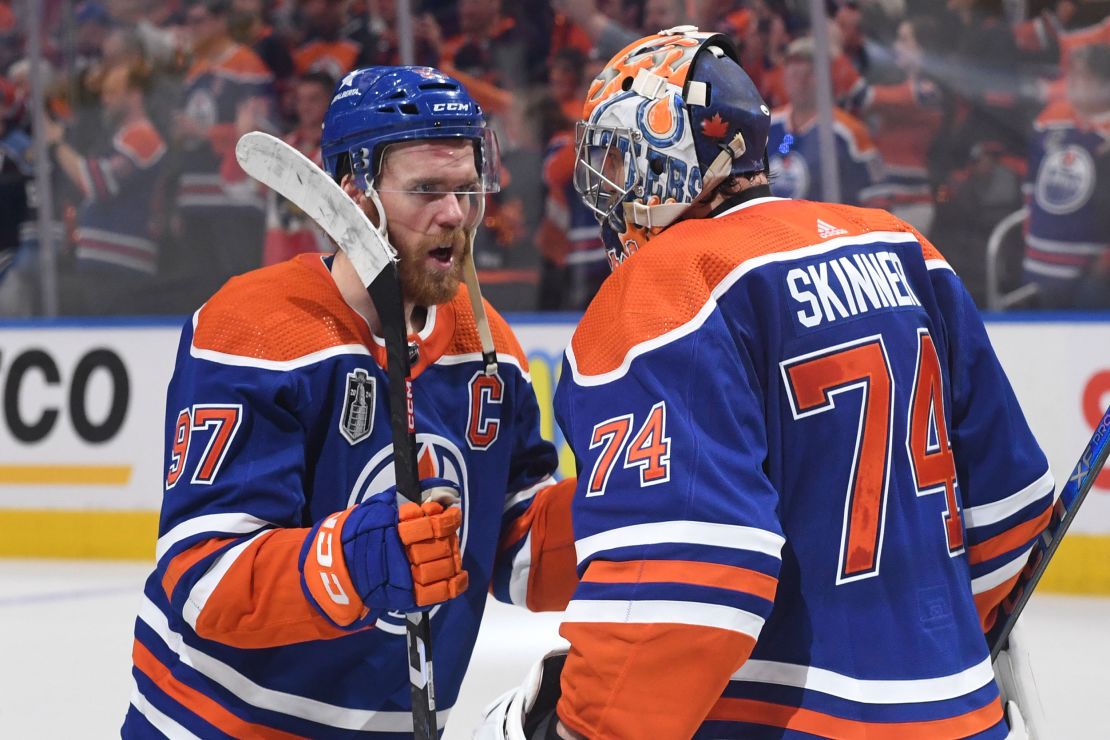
[0,509,1110,595]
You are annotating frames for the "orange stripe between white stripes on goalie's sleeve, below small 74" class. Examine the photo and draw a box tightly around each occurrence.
[582,560,778,601]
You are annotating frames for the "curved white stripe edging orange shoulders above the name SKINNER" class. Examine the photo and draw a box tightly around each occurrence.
[566,231,917,386]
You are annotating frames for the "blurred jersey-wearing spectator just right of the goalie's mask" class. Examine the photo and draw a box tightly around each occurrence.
[767,37,882,205]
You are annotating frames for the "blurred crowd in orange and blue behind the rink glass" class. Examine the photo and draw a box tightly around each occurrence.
[0,0,1110,316]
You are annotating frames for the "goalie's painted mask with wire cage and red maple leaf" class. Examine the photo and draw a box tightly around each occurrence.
[574,26,770,268]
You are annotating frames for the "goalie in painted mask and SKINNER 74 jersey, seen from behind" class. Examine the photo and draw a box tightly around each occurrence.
[480,24,1053,740]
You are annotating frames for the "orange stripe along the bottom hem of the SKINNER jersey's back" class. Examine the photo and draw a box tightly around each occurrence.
[706,698,1002,740]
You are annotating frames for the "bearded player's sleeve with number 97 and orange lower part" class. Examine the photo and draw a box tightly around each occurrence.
[157,319,349,648]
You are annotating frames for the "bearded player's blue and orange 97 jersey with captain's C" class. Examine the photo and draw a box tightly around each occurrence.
[123,254,574,738]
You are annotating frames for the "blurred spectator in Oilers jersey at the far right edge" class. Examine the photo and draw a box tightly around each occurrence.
[1025,44,1110,308]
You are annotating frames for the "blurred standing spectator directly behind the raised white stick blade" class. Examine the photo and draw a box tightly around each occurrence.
[174,0,273,307]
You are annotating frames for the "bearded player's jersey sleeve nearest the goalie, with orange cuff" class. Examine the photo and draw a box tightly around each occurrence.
[490,366,578,611]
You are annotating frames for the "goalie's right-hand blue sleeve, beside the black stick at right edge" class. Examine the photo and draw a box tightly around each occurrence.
[934,270,1056,630]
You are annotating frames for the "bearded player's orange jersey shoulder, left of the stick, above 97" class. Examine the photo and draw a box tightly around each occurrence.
[193,254,371,362]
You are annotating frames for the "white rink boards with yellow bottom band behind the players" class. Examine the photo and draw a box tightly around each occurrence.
[0,314,1110,594]
